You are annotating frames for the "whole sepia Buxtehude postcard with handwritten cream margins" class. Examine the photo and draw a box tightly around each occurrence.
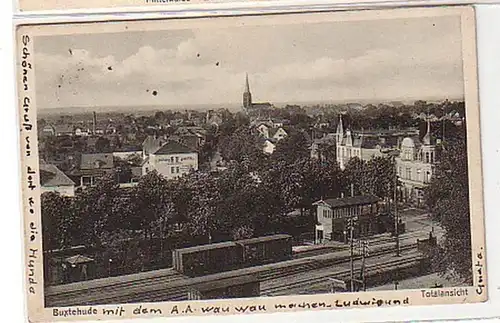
[17,7,487,322]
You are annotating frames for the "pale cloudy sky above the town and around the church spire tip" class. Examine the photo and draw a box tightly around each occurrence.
[35,16,464,109]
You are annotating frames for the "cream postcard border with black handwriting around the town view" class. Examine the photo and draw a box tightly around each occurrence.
[17,7,487,321]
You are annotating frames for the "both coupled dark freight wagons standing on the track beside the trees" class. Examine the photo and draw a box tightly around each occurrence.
[172,234,292,277]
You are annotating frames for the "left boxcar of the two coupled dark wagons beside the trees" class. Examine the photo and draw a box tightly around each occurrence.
[172,242,243,277]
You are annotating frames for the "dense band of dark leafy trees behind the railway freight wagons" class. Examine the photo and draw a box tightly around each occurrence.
[42,137,392,270]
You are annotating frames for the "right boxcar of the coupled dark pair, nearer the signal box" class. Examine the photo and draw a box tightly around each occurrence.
[236,234,293,267]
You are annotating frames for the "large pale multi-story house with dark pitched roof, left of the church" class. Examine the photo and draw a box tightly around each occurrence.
[142,140,198,179]
